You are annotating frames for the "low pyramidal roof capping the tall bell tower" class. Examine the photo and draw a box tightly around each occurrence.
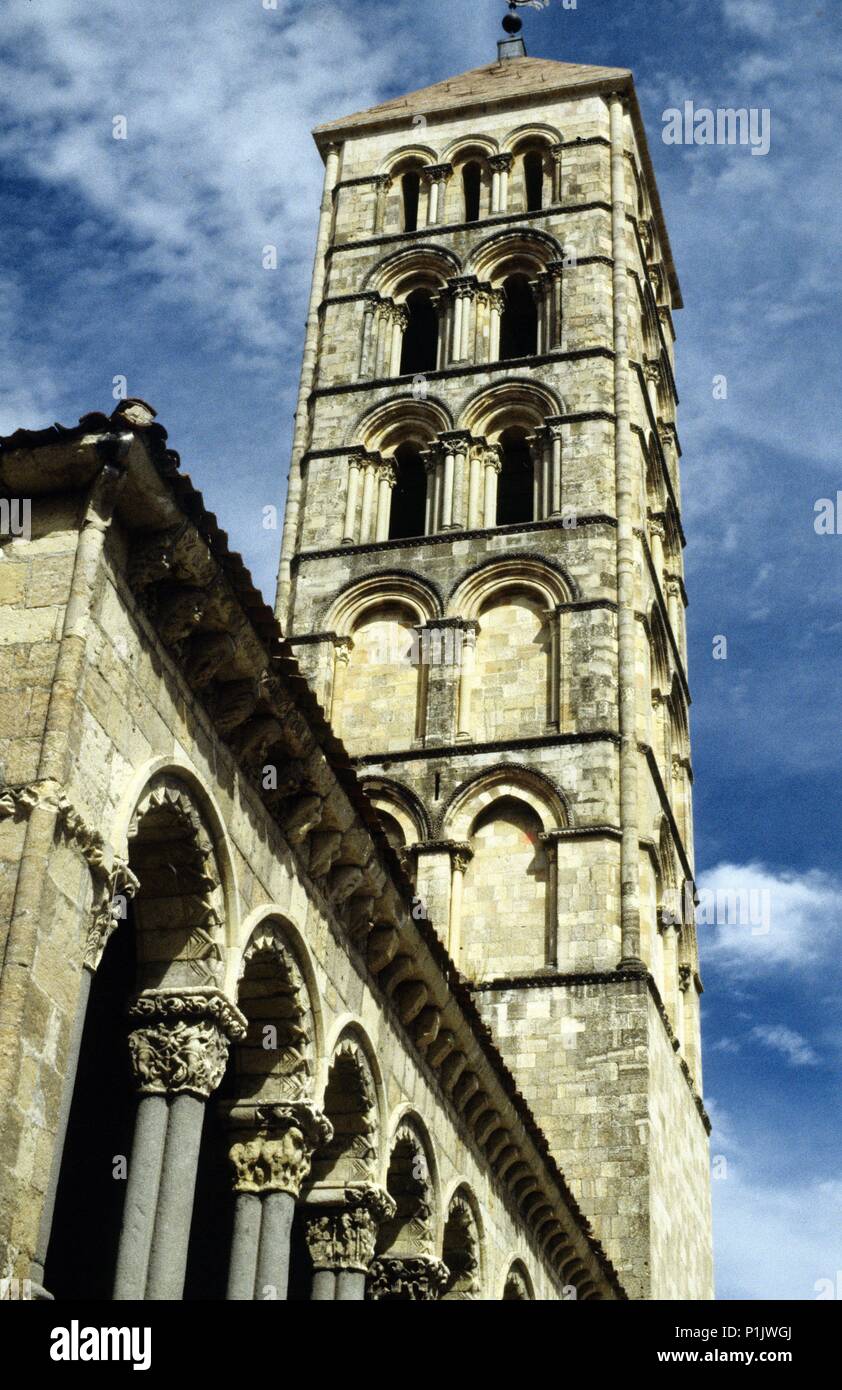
[313,57,631,143]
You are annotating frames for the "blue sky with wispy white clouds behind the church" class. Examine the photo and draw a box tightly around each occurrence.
[0,0,842,1300]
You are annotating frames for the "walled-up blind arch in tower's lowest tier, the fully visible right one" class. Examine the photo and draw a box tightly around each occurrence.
[459,796,549,981]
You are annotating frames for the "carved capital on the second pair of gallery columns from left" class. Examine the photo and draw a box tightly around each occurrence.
[228,1101,333,1198]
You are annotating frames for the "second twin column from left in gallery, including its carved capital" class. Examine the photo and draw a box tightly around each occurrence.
[226,1101,333,1301]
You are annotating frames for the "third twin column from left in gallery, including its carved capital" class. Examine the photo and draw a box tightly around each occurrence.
[304,1183,396,1302]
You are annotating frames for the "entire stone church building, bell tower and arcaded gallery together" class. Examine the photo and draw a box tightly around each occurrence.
[0,43,713,1301]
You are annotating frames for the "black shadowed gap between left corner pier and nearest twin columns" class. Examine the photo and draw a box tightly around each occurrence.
[44,906,138,1301]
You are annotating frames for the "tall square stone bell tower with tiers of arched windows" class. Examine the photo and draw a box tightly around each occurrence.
[278,40,711,1298]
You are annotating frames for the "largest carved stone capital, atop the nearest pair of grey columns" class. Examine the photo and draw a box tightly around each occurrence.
[129,988,246,1099]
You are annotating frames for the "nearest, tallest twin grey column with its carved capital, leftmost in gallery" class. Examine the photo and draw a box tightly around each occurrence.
[114,987,246,1302]
